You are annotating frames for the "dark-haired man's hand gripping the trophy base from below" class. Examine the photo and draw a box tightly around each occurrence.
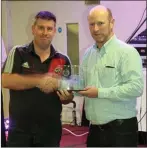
[57,90,74,102]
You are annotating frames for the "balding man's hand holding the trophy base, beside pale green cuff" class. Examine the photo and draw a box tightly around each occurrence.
[78,86,98,98]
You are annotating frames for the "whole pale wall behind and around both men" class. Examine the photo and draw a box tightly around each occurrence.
[2,1,146,126]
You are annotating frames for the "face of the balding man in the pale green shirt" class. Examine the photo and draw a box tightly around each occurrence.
[88,13,114,44]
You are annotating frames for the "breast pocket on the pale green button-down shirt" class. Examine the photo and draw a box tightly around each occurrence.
[99,65,116,88]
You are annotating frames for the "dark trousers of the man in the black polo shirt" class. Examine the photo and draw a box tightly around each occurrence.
[7,122,62,147]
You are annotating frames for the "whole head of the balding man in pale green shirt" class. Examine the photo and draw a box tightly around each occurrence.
[88,5,114,47]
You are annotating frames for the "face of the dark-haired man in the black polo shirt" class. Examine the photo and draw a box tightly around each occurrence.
[32,18,56,49]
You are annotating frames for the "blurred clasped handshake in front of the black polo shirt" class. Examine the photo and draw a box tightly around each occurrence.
[37,75,60,93]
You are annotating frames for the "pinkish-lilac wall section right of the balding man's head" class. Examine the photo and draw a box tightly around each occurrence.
[101,1,146,41]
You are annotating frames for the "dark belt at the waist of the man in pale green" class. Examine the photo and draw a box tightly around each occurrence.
[91,117,136,130]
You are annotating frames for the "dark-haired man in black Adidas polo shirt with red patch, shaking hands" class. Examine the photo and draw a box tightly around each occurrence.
[2,11,73,147]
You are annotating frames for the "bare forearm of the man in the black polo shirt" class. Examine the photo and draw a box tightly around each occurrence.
[2,74,43,90]
